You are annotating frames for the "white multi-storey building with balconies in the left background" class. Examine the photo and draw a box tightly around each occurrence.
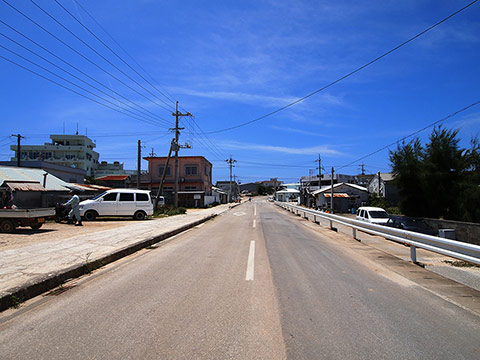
[10,135,123,176]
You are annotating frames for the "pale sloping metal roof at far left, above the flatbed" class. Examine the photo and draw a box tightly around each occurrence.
[0,166,69,191]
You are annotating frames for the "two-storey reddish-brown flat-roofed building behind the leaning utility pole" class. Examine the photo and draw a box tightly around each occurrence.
[142,156,212,207]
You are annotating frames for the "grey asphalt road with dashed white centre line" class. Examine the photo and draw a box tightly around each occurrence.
[0,201,480,359]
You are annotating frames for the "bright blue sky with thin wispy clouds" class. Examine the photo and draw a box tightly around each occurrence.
[0,0,480,183]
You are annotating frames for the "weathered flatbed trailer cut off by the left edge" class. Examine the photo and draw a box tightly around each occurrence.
[0,208,55,233]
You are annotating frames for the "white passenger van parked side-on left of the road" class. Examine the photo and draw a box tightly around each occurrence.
[80,189,153,221]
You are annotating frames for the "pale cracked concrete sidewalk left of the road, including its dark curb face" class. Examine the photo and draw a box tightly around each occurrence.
[0,204,236,311]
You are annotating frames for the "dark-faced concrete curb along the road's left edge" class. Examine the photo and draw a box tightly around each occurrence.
[0,214,217,312]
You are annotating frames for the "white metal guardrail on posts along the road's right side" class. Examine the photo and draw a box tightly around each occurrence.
[275,201,480,265]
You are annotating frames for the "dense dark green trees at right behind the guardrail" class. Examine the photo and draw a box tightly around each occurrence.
[390,126,480,222]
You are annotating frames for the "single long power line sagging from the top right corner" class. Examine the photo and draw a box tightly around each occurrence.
[204,0,479,134]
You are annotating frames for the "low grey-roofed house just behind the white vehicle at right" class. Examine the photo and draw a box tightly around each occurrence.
[312,183,368,213]
